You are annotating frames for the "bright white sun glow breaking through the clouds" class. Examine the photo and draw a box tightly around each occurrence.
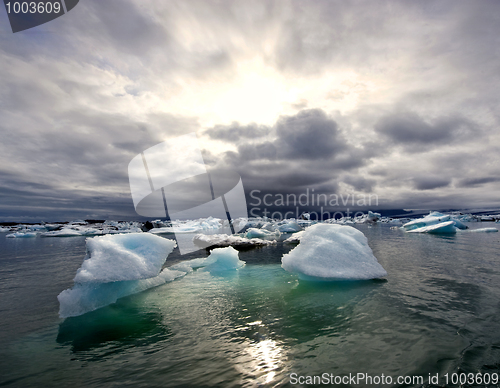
[152,57,376,128]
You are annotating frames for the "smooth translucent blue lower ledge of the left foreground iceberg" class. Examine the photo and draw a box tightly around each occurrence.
[57,268,186,318]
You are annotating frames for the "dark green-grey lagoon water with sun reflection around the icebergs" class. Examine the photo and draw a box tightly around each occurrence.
[0,223,500,387]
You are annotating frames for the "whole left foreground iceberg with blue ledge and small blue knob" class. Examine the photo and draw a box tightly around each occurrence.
[57,233,245,318]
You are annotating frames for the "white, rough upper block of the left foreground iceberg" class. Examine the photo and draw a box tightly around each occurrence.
[74,233,176,283]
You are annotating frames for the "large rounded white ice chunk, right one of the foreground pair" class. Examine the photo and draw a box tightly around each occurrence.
[281,224,387,280]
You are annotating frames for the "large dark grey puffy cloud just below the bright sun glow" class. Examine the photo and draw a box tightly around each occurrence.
[201,109,374,209]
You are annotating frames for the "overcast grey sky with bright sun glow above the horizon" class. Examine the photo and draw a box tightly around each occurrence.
[0,0,500,222]
